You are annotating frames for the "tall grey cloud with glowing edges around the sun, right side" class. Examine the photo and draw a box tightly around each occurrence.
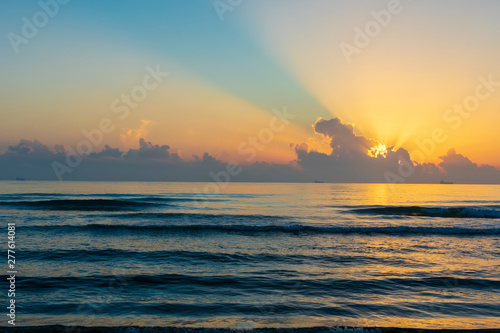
[293,118,500,183]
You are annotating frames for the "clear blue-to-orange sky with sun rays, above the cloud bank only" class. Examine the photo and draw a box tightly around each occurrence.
[0,0,500,176]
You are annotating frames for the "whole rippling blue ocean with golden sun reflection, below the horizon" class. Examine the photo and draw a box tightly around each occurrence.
[0,181,500,331]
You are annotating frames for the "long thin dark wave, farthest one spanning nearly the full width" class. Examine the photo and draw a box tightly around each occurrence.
[23,223,500,236]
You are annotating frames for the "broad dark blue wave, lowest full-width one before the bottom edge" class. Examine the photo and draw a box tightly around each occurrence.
[8,273,500,296]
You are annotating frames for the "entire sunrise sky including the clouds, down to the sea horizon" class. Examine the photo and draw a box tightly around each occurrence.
[0,0,500,183]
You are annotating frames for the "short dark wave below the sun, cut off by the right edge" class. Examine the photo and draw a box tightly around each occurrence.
[349,206,500,219]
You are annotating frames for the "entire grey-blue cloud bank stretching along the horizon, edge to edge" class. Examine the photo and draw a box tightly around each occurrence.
[0,118,500,184]
